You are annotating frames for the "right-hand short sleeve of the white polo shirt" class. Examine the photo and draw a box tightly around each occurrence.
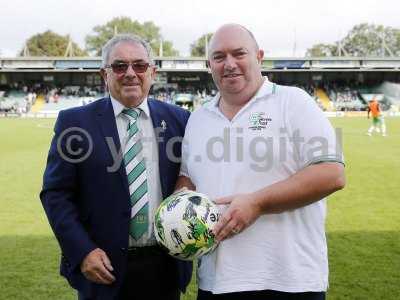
[286,88,344,169]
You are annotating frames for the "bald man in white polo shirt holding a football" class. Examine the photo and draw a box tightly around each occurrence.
[177,24,345,300]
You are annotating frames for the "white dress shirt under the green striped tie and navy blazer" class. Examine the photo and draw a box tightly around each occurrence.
[110,96,162,247]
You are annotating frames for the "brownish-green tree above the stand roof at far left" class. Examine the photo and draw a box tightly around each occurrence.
[19,30,87,56]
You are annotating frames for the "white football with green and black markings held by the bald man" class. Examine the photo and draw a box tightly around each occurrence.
[154,190,219,260]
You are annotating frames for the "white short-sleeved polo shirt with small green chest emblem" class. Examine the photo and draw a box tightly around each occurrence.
[181,80,342,294]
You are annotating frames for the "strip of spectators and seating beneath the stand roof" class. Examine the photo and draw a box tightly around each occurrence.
[0,77,400,116]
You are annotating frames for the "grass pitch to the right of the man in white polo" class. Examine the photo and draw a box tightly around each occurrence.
[327,118,400,299]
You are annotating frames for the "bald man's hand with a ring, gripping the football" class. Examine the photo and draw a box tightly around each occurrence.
[213,194,261,241]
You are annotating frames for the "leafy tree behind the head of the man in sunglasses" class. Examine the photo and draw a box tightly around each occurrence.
[85,17,179,56]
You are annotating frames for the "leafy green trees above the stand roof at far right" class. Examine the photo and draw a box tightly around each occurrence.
[306,23,400,57]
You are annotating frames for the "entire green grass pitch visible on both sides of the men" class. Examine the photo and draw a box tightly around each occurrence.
[0,118,400,300]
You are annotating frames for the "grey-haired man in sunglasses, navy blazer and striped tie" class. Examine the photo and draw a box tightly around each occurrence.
[40,35,191,300]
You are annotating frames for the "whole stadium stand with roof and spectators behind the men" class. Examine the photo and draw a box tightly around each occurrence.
[0,57,400,115]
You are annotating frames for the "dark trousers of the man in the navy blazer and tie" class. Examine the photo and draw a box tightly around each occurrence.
[78,247,180,300]
